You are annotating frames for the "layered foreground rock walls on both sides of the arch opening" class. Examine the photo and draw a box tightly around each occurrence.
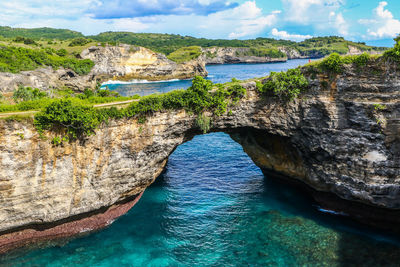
[0,64,400,252]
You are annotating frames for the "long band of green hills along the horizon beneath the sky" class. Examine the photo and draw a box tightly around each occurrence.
[0,27,386,66]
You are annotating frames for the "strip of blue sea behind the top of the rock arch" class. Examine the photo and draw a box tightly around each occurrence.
[103,59,308,96]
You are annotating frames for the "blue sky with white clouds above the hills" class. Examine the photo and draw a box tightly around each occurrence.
[0,0,400,46]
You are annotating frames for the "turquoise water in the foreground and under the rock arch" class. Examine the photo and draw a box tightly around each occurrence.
[0,61,400,267]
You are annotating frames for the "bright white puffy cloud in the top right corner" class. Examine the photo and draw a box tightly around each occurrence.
[359,1,400,38]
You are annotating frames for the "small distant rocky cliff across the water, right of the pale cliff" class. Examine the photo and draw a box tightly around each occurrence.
[203,47,287,65]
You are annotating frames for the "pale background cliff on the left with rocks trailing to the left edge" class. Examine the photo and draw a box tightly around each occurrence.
[0,45,207,92]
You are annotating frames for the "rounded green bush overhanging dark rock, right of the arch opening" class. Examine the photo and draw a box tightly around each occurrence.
[259,69,308,101]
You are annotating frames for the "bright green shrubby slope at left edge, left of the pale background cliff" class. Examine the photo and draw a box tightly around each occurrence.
[0,46,94,75]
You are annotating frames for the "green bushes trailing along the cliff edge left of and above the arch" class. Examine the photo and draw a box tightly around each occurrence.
[34,77,246,140]
